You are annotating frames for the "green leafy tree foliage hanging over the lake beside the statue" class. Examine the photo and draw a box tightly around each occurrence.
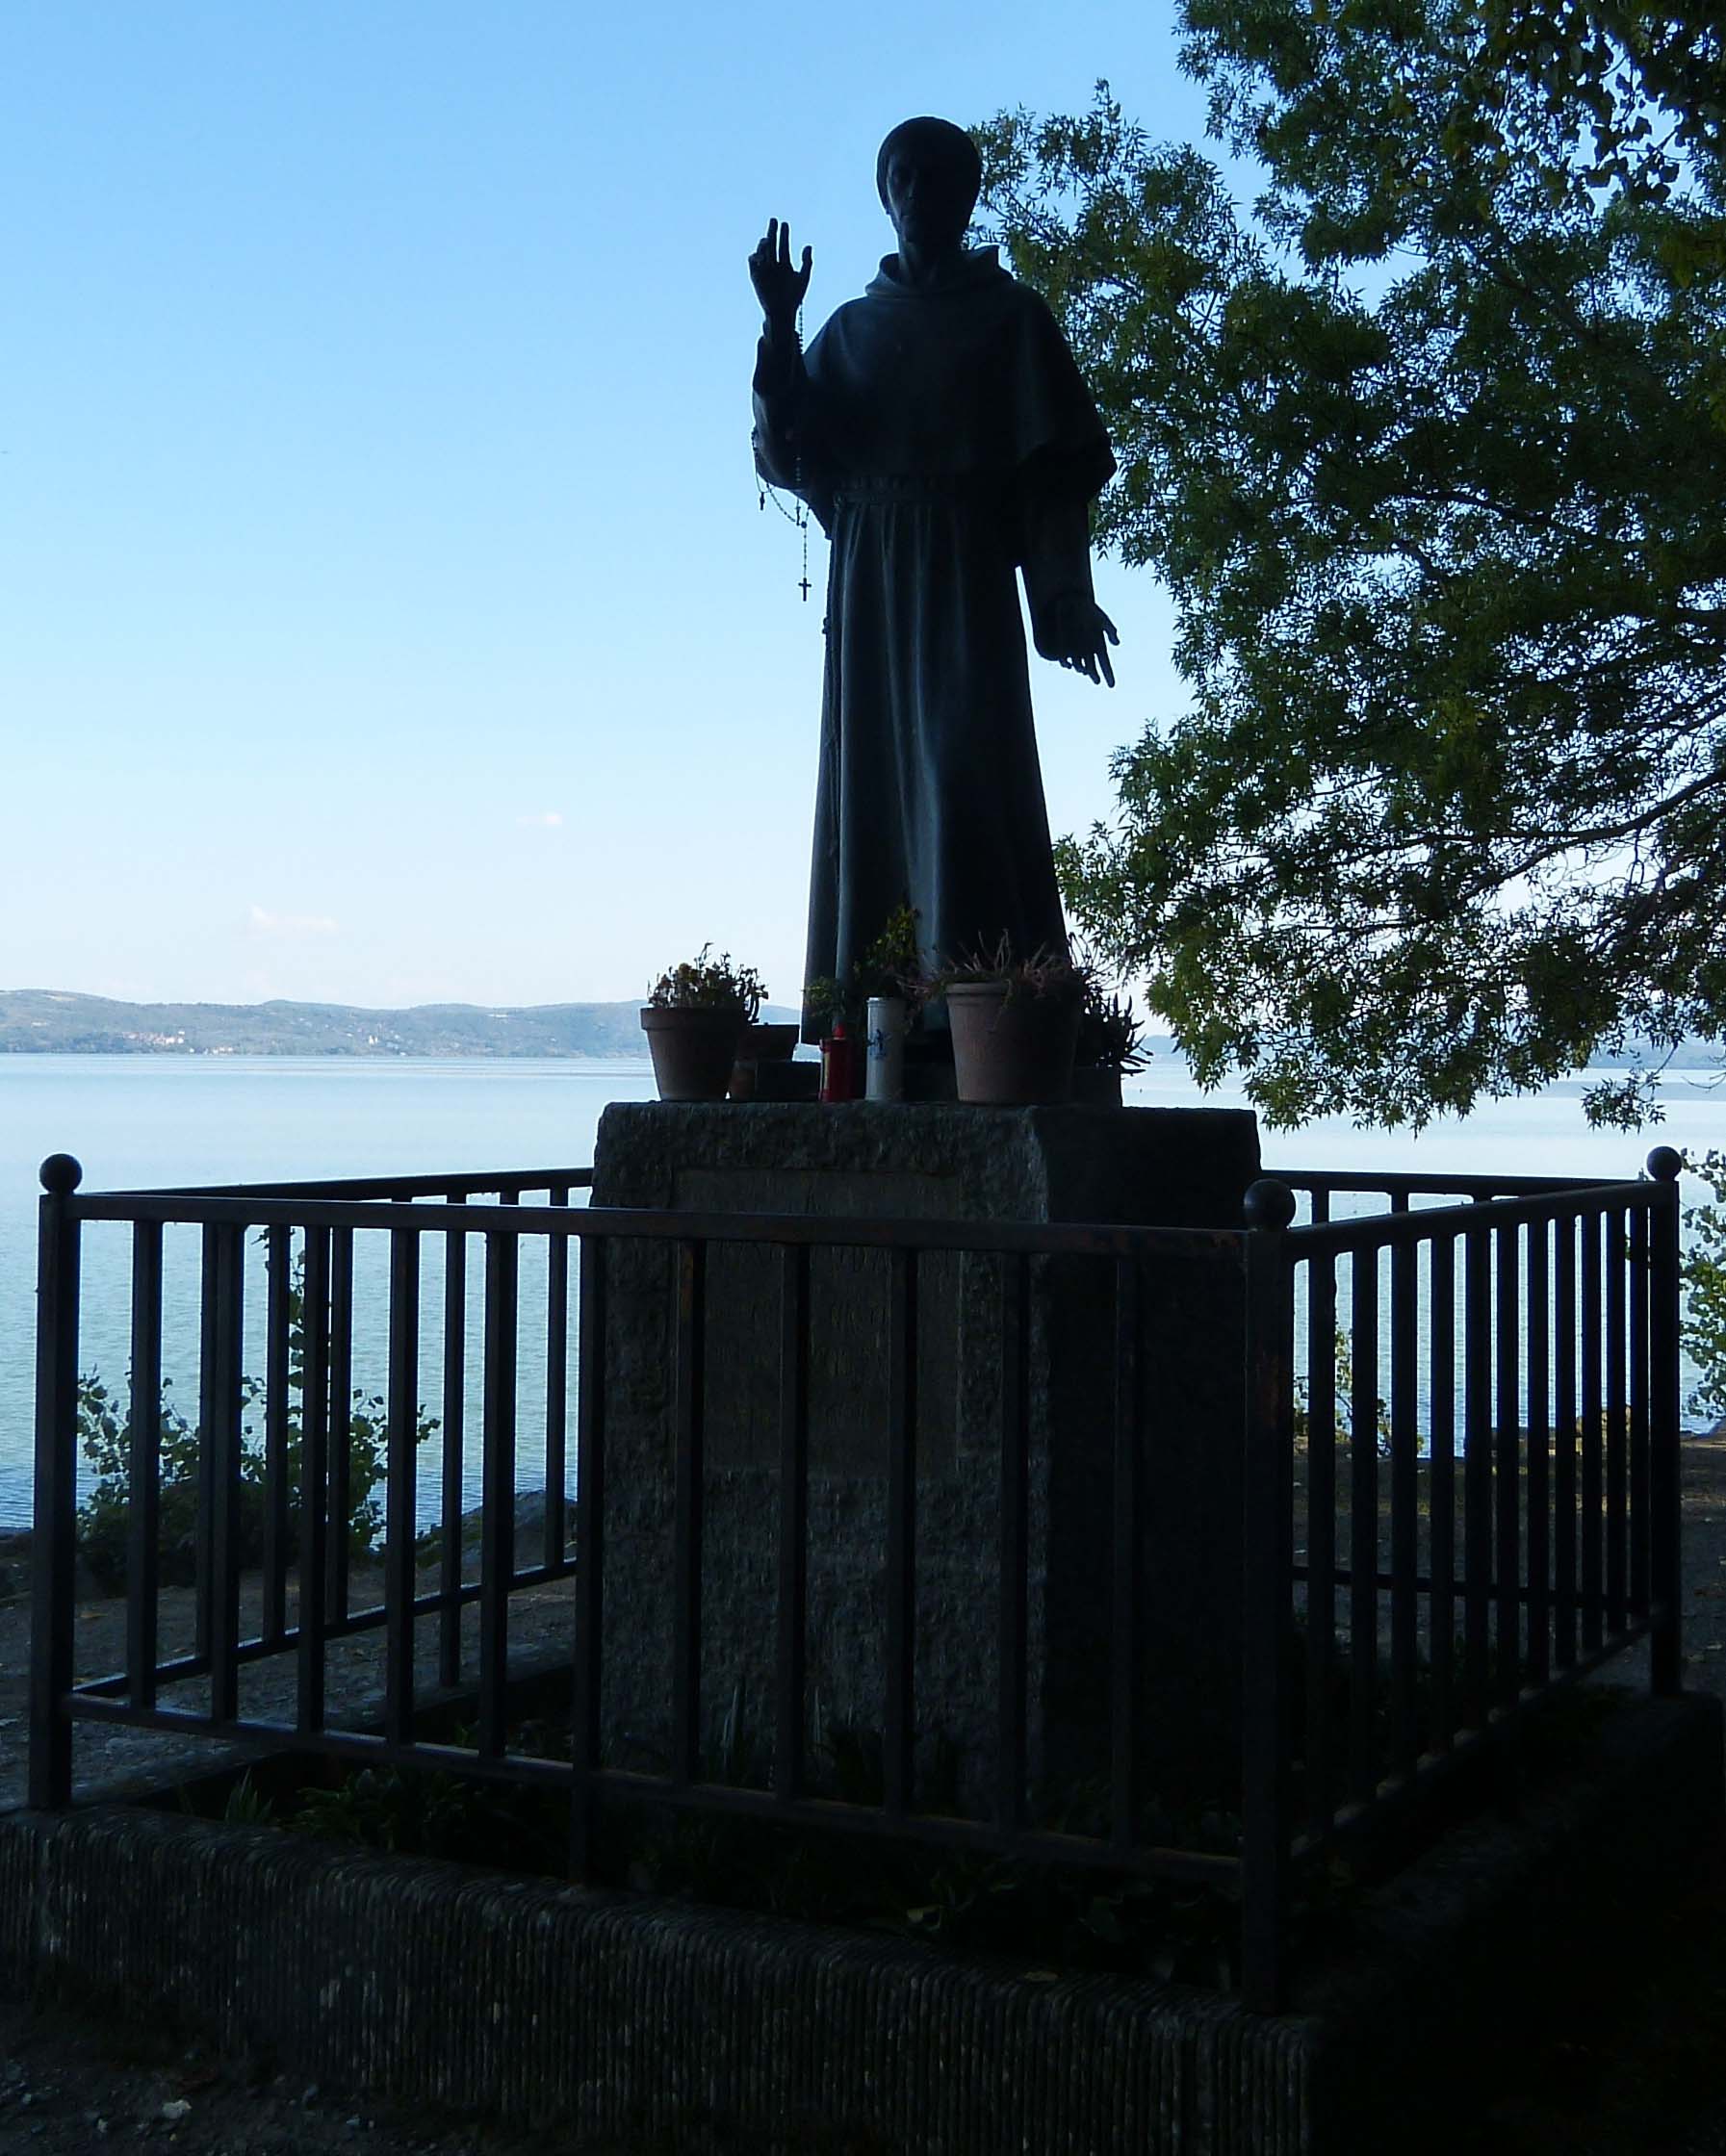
[980,0,1726,1123]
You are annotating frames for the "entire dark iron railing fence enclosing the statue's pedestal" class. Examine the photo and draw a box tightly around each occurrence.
[30,1149,1681,2007]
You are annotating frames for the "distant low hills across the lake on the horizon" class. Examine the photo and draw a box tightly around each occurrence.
[0,988,694,1057]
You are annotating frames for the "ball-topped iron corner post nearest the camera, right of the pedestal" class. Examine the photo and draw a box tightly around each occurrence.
[1241,1177,1295,2014]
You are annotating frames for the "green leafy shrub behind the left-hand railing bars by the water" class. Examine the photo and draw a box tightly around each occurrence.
[78,1259,438,1591]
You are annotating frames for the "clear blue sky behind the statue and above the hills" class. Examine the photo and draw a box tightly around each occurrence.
[0,0,1204,1005]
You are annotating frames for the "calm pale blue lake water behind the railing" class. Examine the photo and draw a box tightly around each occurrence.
[0,1057,1726,1528]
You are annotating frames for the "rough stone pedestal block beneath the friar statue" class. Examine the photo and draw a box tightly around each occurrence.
[593,1102,1260,1824]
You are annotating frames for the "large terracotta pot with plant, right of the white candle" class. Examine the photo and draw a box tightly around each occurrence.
[934,937,1088,1106]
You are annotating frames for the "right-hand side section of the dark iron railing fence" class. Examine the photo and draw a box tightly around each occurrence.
[1286,1149,1681,1850]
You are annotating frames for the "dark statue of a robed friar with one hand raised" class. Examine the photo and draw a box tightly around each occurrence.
[749,118,1118,1031]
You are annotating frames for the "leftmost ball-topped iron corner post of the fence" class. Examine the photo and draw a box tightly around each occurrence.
[30,1153,84,1811]
